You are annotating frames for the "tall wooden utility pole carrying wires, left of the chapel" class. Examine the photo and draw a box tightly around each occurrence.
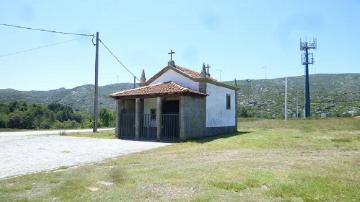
[93,32,99,133]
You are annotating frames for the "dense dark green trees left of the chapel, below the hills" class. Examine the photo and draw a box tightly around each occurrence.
[0,101,115,129]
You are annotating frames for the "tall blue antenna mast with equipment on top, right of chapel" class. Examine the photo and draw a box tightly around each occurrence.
[300,38,317,118]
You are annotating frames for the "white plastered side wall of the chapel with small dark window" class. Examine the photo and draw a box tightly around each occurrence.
[206,83,235,127]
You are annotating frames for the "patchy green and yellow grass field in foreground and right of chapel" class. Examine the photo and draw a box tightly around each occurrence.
[0,118,360,201]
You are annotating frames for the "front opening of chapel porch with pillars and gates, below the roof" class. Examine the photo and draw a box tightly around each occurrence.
[117,97,180,141]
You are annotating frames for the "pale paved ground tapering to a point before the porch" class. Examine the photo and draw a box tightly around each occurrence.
[0,132,169,178]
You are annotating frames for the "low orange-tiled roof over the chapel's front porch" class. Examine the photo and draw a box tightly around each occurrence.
[110,82,206,98]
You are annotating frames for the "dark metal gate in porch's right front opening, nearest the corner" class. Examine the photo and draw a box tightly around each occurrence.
[160,114,180,141]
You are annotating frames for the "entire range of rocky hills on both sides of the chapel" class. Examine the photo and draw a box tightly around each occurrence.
[0,74,360,118]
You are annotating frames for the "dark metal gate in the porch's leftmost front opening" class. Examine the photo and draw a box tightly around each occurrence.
[119,113,135,139]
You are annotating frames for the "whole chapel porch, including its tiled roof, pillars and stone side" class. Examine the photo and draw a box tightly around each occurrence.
[111,82,206,141]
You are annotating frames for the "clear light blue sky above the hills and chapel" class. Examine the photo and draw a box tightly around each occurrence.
[0,0,360,90]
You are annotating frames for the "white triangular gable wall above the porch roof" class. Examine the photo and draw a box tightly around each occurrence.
[151,69,199,91]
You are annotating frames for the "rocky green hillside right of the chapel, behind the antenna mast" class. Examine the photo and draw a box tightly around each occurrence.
[226,74,360,118]
